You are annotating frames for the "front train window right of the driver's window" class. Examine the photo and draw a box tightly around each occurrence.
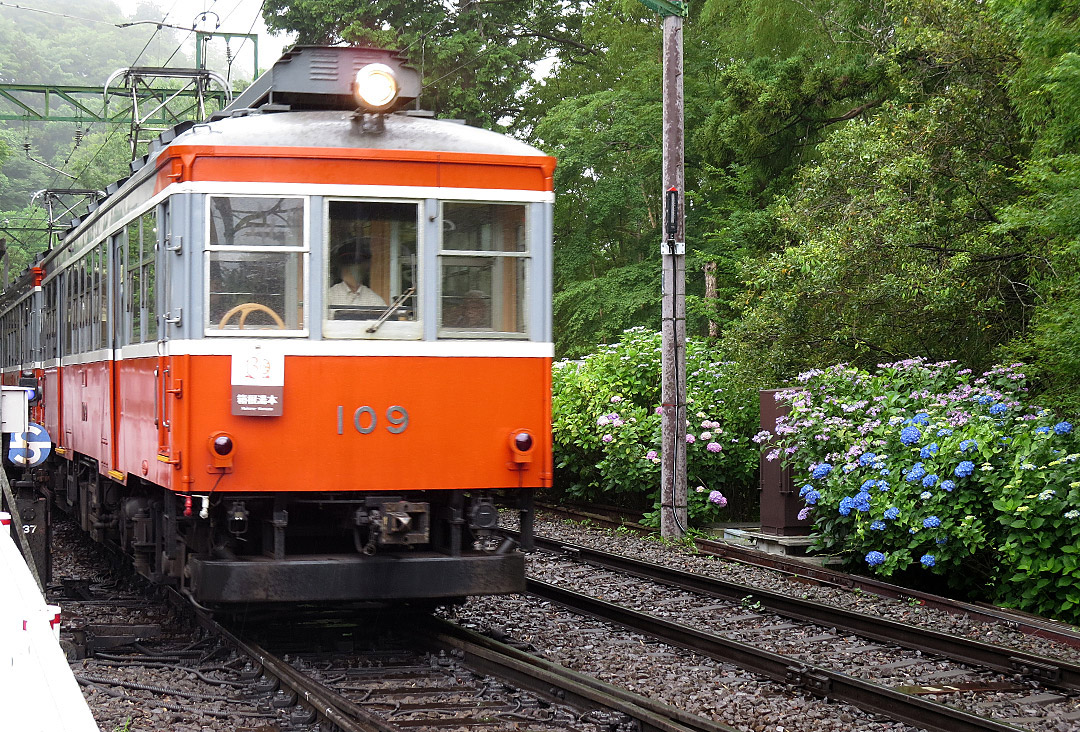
[440,202,528,338]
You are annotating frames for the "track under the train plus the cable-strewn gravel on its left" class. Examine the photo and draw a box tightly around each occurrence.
[51,518,732,732]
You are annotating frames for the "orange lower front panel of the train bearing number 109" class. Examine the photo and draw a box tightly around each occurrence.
[172,356,551,492]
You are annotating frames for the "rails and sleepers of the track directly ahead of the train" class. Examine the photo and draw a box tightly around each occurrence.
[213,615,747,732]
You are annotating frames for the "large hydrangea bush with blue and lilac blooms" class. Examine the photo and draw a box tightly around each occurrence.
[758,358,1080,622]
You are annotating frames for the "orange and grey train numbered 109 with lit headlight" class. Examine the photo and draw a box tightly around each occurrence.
[0,46,555,605]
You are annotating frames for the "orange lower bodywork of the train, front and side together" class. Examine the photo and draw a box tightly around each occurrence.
[36,355,552,492]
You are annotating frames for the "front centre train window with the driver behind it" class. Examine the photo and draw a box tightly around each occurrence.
[324,200,419,338]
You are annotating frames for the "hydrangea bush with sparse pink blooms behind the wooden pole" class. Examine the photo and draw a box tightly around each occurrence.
[552,328,759,526]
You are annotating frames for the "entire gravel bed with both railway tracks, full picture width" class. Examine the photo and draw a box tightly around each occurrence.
[46,509,1080,732]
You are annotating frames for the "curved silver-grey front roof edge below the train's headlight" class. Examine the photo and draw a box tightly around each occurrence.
[168,110,546,157]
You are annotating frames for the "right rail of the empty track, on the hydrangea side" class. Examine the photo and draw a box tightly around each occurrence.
[536,537,1080,691]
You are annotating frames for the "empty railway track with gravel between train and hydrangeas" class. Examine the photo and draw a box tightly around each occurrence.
[518,538,1080,732]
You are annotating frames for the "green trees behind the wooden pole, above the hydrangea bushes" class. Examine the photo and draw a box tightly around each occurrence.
[526,0,1080,408]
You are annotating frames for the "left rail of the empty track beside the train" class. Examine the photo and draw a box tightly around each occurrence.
[526,580,1022,732]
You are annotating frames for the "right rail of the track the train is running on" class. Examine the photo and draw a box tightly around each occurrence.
[423,618,735,732]
